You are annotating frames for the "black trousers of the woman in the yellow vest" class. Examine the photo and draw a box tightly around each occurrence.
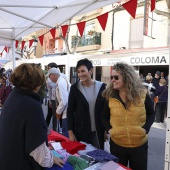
[110,139,148,170]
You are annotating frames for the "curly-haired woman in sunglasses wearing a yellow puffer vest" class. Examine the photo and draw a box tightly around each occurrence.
[102,63,155,170]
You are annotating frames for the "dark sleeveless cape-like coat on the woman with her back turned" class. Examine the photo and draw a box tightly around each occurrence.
[0,87,47,170]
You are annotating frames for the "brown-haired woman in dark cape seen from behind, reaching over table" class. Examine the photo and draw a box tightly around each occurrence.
[0,63,63,170]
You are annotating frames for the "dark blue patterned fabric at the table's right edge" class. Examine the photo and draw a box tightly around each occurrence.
[87,149,119,162]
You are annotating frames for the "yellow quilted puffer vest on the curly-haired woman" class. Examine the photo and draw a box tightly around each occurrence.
[109,91,147,147]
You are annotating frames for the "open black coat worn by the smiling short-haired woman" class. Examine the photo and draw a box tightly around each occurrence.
[67,83,106,149]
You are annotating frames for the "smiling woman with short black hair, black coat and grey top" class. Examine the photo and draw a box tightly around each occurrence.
[67,59,106,149]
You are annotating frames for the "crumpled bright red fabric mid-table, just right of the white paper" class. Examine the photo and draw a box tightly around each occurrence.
[61,141,86,154]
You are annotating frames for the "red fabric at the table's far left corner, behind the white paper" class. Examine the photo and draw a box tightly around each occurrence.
[48,130,70,142]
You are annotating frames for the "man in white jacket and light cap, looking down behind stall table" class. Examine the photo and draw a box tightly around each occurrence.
[48,68,71,137]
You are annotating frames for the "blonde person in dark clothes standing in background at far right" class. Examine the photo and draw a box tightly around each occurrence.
[154,79,168,123]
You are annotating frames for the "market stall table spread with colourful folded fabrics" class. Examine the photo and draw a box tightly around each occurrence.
[46,130,130,170]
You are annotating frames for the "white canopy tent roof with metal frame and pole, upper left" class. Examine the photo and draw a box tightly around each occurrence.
[0,0,127,67]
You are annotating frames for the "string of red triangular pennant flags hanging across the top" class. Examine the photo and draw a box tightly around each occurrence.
[0,0,155,56]
